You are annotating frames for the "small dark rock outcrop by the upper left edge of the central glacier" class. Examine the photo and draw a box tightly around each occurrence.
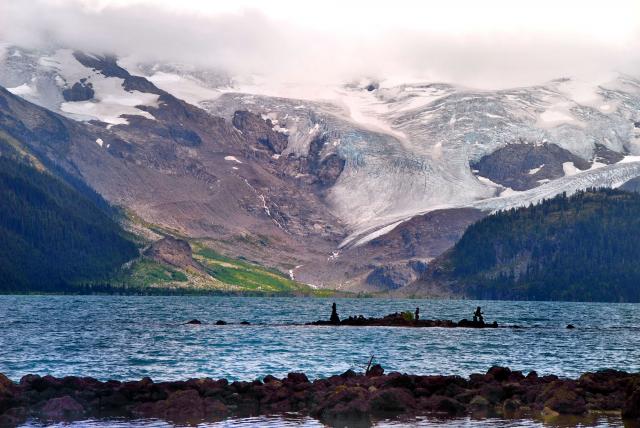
[233,111,288,154]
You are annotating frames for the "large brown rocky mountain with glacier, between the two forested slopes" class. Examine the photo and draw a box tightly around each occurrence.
[0,45,640,291]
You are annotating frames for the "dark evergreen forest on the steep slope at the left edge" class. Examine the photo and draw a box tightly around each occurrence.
[0,145,138,292]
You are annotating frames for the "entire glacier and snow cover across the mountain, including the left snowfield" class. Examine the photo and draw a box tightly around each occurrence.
[0,46,640,247]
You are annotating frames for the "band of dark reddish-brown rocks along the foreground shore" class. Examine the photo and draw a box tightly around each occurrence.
[0,365,640,426]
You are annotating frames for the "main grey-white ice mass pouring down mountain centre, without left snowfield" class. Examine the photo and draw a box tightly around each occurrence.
[203,73,640,245]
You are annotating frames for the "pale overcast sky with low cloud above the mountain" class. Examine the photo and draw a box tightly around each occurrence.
[0,0,640,88]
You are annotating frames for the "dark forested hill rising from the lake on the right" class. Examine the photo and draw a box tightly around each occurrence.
[405,189,640,302]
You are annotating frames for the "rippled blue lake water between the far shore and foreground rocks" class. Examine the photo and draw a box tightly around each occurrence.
[0,296,640,426]
